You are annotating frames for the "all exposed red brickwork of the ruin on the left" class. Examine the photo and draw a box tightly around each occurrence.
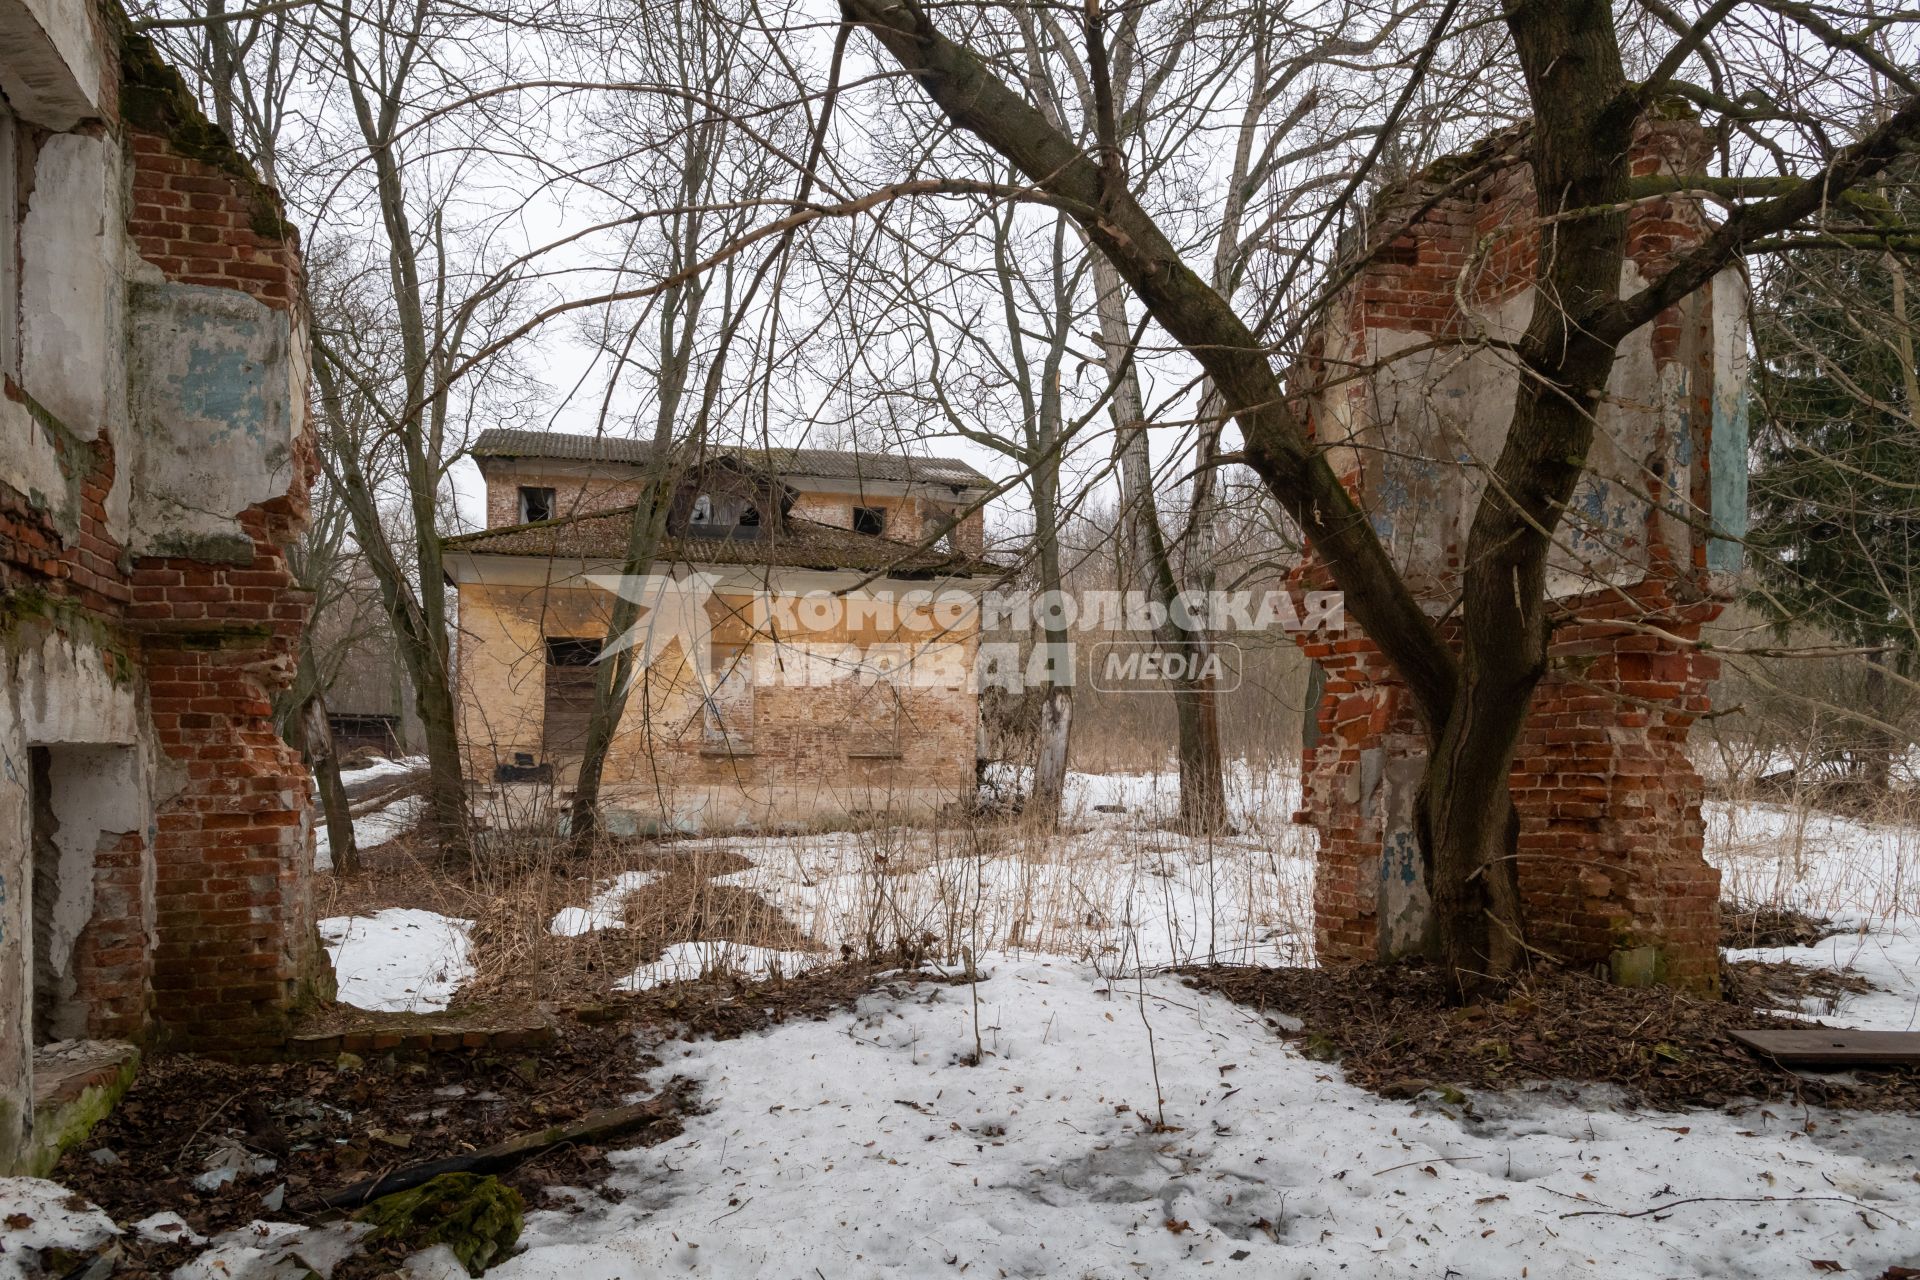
[0,42,319,1054]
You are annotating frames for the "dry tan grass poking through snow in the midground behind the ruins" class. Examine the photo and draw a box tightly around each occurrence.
[319,729,1920,1006]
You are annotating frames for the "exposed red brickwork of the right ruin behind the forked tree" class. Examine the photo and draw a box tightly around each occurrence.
[1300,121,1722,990]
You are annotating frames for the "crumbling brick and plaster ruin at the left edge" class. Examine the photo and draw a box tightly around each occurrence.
[0,0,328,1173]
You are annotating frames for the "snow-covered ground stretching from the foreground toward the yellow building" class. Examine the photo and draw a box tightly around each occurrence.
[45,770,1889,1280]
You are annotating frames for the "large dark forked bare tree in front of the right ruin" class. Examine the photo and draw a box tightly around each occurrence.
[843,0,1920,988]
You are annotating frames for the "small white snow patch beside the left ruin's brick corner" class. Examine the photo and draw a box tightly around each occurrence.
[321,908,474,1013]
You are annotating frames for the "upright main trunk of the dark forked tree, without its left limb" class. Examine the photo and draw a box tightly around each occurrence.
[1423,0,1640,994]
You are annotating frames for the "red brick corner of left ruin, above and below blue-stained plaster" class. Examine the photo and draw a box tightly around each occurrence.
[129,87,324,1052]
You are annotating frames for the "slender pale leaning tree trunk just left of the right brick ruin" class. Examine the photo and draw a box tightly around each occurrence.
[1092,253,1227,835]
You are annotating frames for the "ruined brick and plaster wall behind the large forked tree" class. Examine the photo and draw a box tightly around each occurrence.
[1300,121,1745,988]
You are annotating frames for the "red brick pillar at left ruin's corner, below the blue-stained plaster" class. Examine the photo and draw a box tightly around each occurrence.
[131,503,324,1054]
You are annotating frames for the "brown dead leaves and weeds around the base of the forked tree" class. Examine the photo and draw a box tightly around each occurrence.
[1185,963,1920,1111]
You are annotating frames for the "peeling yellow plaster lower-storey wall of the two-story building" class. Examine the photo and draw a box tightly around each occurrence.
[459,557,979,831]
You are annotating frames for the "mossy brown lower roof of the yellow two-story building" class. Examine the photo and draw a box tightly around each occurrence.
[445,507,1000,578]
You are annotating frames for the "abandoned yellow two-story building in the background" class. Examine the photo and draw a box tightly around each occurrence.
[445,430,998,831]
